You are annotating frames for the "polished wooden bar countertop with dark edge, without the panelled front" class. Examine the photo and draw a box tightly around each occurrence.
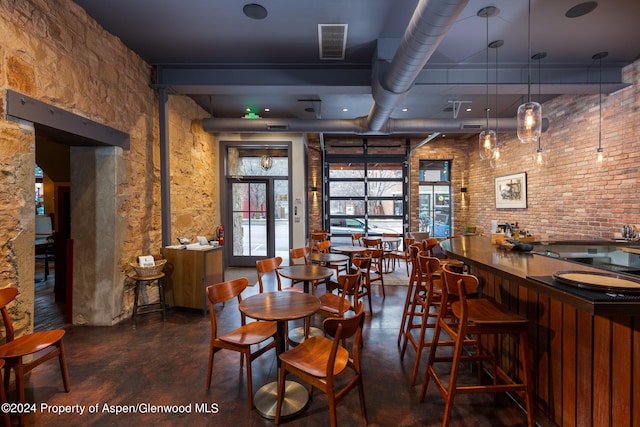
[440,236,640,316]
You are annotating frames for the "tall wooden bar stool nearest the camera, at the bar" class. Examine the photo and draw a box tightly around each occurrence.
[420,265,535,427]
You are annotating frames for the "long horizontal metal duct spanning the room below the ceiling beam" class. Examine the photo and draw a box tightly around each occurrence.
[202,117,549,135]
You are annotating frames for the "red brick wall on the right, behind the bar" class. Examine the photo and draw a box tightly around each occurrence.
[469,61,640,240]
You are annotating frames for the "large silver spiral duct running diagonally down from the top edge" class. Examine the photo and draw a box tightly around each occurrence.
[368,0,469,131]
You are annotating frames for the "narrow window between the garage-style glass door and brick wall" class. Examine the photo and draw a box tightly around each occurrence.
[419,160,453,237]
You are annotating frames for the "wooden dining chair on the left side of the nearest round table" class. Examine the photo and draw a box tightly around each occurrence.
[206,277,276,409]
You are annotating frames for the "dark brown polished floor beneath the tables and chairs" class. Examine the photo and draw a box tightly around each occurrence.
[20,262,526,427]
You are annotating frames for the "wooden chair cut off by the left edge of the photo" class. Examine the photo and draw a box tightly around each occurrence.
[0,287,71,425]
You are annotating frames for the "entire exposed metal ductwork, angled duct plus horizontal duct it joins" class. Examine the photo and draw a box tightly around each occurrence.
[202,0,549,135]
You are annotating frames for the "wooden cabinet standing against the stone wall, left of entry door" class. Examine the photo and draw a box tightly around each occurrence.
[162,247,224,311]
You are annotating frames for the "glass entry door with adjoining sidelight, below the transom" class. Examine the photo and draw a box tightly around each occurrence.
[227,178,289,267]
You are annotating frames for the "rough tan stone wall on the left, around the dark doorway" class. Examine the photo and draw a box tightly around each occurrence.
[0,0,219,330]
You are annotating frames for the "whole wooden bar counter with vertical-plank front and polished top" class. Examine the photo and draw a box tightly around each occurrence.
[441,236,640,427]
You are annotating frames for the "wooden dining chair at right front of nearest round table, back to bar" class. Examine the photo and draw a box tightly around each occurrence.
[275,302,368,427]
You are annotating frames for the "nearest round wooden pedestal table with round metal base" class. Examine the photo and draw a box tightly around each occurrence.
[239,292,320,419]
